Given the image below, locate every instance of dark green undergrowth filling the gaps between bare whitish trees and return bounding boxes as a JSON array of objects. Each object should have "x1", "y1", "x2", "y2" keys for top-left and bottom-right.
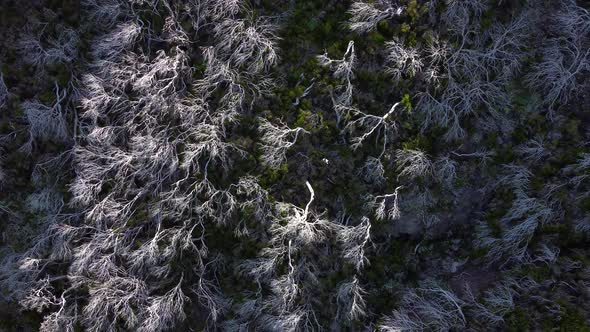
[{"x1": 0, "y1": 0, "x2": 590, "y2": 332}]
